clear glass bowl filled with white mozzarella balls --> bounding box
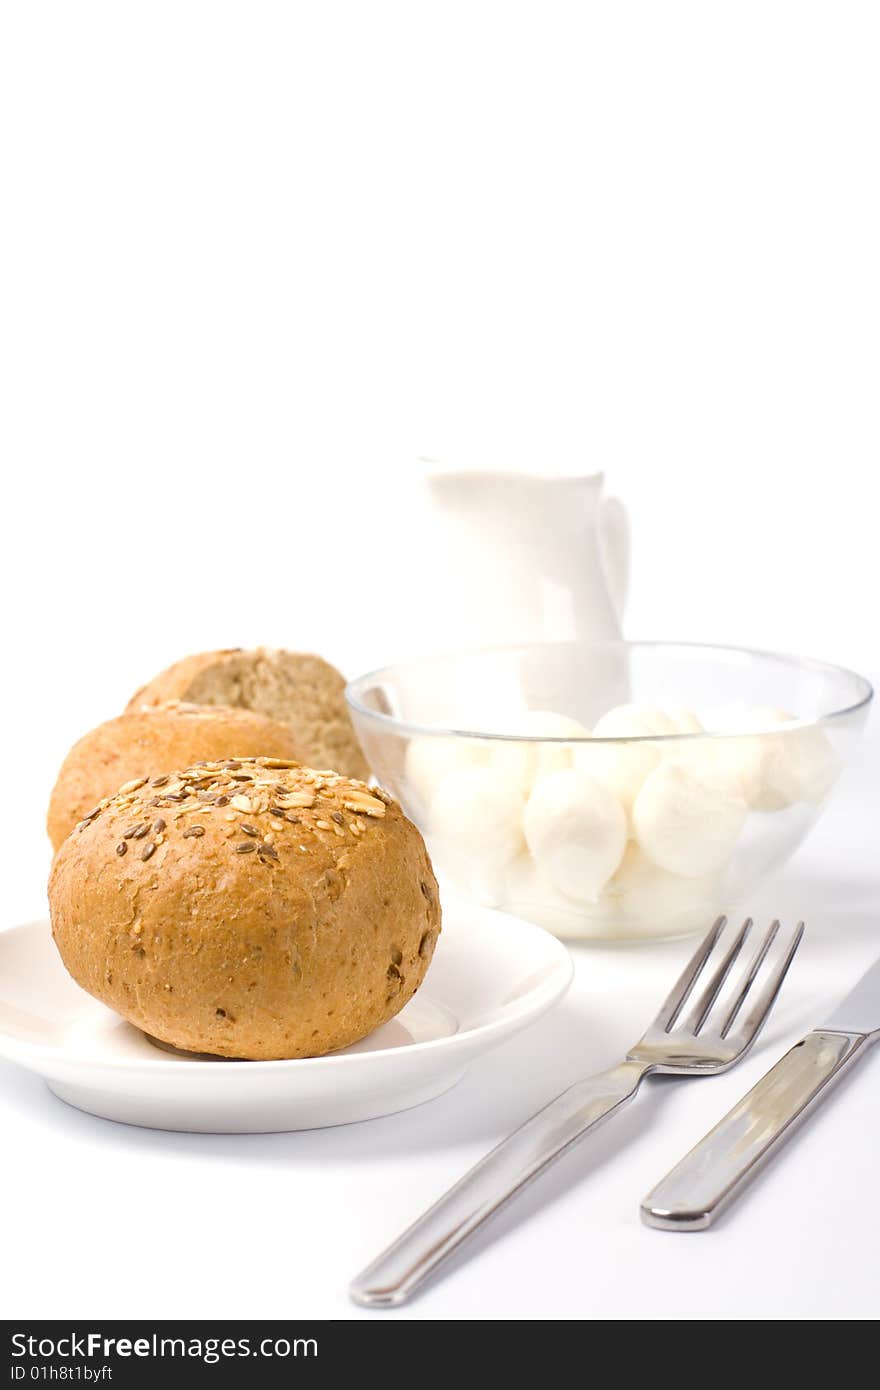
[346,642,873,940]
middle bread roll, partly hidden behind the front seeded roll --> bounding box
[46,701,299,849]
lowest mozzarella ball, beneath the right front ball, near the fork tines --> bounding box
[605,842,719,937]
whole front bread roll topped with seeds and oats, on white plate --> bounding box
[49,758,441,1059]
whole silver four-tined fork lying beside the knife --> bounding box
[350,917,804,1308]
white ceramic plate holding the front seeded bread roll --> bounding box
[0,902,571,1133]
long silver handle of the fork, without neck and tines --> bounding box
[350,1061,648,1308]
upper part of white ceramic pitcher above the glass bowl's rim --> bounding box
[421,459,630,649]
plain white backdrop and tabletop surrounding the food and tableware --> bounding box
[0,0,880,1318]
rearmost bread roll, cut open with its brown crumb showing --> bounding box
[128,646,370,778]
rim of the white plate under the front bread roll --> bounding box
[0,902,574,1077]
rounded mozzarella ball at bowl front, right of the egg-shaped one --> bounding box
[633,759,748,878]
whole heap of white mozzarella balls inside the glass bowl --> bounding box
[406,705,838,937]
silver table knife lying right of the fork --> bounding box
[642,960,880,1230]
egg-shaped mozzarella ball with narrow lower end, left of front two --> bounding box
[523,767,627,902]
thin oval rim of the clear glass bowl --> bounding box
[345,639,874,745]
